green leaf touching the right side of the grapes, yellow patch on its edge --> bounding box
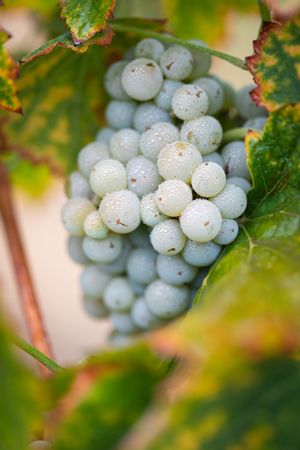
[198,105,300,299]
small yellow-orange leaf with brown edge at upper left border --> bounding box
[0,27,22,113]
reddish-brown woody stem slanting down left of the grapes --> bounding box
[0,161,52,376]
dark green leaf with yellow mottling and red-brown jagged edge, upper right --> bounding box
[246,16,300,111]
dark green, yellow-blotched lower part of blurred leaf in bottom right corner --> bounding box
[142,357,300,450]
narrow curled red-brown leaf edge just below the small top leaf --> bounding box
[20,25,114,65]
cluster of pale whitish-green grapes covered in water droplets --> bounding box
[62,39,265,342]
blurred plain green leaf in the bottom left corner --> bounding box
[0,312,40,450]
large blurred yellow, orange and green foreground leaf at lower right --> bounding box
[137,250,300,450]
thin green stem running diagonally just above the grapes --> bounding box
[110,22,248,70]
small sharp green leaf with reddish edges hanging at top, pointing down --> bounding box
[62,0,115,44]
